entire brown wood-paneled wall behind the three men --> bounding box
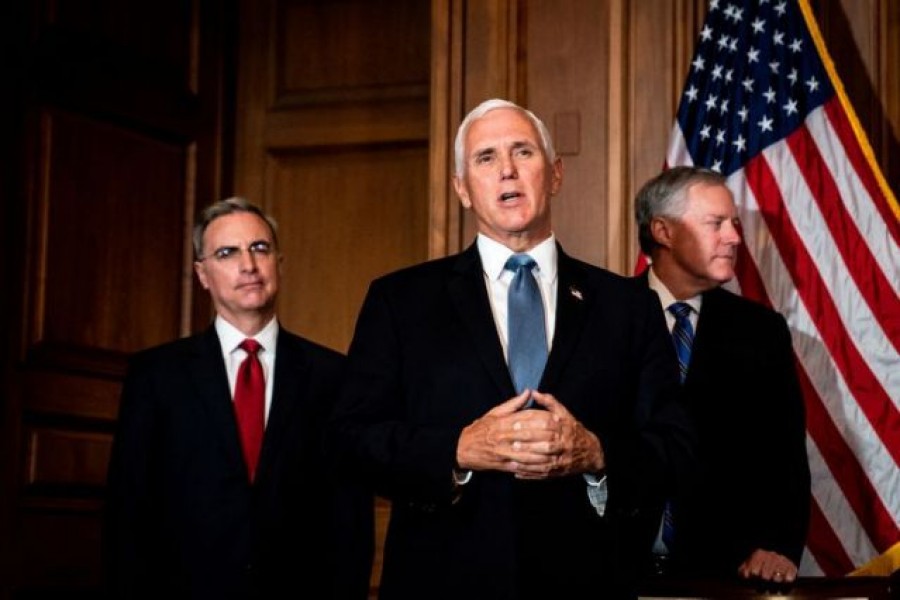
[0,0,900,600]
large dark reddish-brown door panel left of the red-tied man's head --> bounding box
[28,111,191,364]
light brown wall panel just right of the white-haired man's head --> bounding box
[522,0,619,264]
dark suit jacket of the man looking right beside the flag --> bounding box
[643,276,810,577]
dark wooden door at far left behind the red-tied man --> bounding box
[0,0,227,599]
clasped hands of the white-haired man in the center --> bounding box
[456,390,606,479]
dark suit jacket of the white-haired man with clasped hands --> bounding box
[335,245,692,599]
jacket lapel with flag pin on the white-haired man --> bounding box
[539,247,594,390]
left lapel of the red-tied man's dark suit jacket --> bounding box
[189,327,245,468]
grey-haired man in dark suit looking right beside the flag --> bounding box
[635,167,810,582]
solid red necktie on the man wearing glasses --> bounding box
[234,339,266,481]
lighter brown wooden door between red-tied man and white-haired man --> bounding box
[234,0,430,591]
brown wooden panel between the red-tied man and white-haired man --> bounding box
[266,144,428,352]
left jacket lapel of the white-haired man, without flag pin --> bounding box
[447,244,515,398]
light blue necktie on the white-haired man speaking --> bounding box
[504,254,547,406]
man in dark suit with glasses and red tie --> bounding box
[105,198,374,599]
